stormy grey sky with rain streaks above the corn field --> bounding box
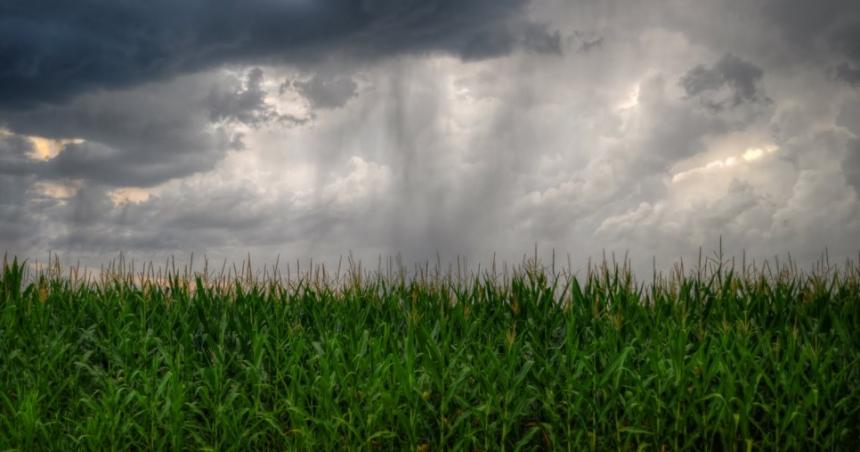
[0,0,860,267]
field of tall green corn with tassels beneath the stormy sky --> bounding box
[0,254,860,451]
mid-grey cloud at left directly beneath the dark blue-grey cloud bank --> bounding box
[0,76,244,186]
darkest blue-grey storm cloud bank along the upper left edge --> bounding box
[0,0,558,108]
